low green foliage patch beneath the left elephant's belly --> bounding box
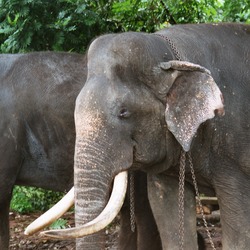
[10,186,63,213]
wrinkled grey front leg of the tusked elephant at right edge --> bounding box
[214,165,250,250]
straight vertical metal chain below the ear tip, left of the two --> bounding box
[178,151,186,250]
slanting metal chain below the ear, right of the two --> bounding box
[187,152,216,250]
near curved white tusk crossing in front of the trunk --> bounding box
[40,171,128,239]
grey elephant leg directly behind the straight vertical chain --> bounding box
[148,174,198,250]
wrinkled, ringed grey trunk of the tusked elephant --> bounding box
[74,137,116,249]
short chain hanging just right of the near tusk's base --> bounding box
[129,172,135,233]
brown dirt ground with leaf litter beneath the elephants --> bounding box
[10,212,222,250]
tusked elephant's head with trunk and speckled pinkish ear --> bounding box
[40,33,223,249]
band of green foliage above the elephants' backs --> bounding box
[0,0,250,53]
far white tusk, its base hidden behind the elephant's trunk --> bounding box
[24,187,74,235]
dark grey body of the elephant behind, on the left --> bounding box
[0,52,86,250]
